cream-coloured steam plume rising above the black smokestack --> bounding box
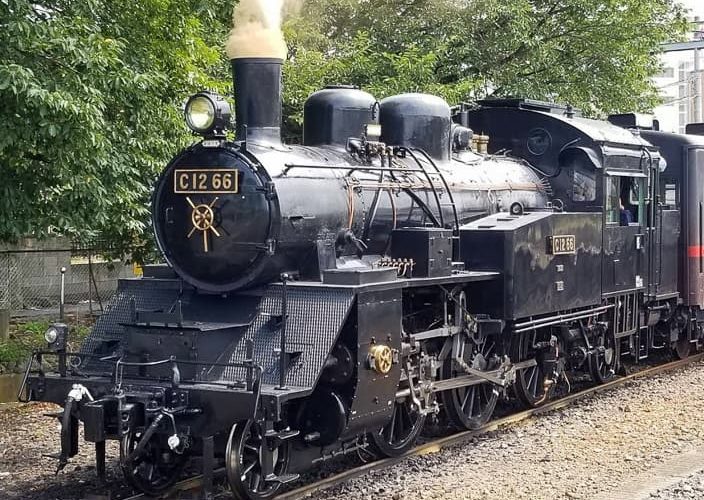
[226,0,288,59]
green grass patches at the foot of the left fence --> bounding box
[0,319,90,373]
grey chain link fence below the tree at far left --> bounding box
[0,245,135,317]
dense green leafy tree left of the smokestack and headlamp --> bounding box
[0,0,230,256]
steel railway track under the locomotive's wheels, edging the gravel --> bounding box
[117,353,704,500]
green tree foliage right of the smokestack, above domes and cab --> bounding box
[287,0,686,132]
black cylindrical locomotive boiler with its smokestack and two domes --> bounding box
[153,58,546,293]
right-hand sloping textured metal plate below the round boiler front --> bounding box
[222,285,354,387]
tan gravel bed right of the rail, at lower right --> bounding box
[311,363,704,500]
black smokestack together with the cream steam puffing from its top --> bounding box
[227,0,287,143]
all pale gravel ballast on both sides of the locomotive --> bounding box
[0,363,704,500]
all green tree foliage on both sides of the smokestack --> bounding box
[0,0,685,247]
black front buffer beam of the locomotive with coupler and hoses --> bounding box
[23,352,262,488]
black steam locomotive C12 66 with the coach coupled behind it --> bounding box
[23,54,704,499]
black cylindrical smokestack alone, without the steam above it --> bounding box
[232,57,284,144]
